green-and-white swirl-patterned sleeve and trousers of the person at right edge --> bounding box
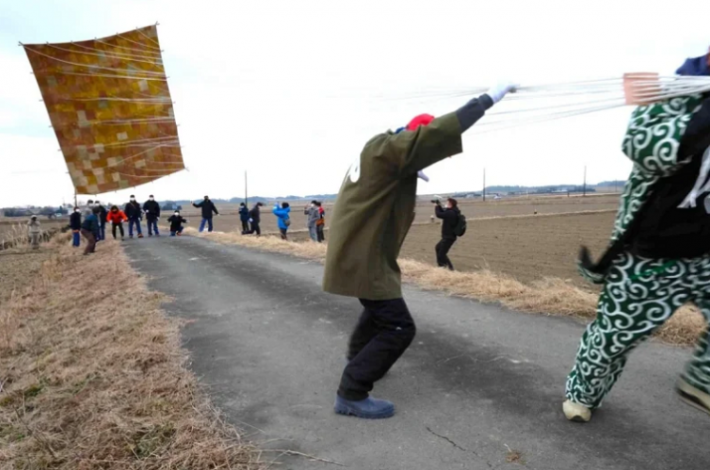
[566,95,710,408]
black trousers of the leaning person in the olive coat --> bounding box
[338,299,417,400]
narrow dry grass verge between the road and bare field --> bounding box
[195,229,706,345]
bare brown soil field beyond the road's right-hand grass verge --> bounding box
[177,194,619,290]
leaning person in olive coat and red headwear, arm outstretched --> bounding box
[323,83,515,418]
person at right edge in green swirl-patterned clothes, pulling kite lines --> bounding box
[563,50,710,422]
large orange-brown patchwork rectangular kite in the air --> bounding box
[23,26,185,195]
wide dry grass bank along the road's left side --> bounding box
[0,234,263,470]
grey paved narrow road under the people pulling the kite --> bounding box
[125,237,710,470]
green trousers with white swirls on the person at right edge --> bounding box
[566,253,710,408]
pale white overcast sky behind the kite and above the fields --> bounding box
[0,0,710,206]
